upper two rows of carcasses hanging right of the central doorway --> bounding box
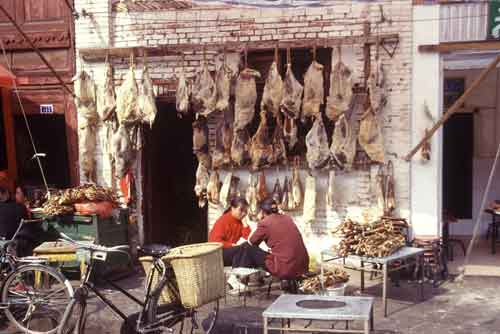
[176,48,387,170]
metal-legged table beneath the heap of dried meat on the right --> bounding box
[320,247,424,317]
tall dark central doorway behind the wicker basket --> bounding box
[143,103,207,246]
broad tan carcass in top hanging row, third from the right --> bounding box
[302,60,325,121]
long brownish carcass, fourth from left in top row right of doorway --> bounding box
[234,68,260,131]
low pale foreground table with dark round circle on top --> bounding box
[262,294,373,334]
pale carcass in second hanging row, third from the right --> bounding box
[306,115,330,169]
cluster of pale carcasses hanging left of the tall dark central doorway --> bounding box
[74,56,157,184]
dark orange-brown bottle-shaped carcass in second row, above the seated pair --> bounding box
[250,112,275,170]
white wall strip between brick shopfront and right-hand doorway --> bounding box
[410,5,443,235]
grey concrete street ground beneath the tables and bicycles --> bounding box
[0,245,500,334]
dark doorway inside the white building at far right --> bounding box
[443,113,474,219]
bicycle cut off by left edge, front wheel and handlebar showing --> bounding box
[0,219,73,334]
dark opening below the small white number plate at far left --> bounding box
[14,115,70,188]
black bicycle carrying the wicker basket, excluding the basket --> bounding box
[58,234,219,334]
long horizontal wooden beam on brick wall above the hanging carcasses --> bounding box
[79,34,399,61]
